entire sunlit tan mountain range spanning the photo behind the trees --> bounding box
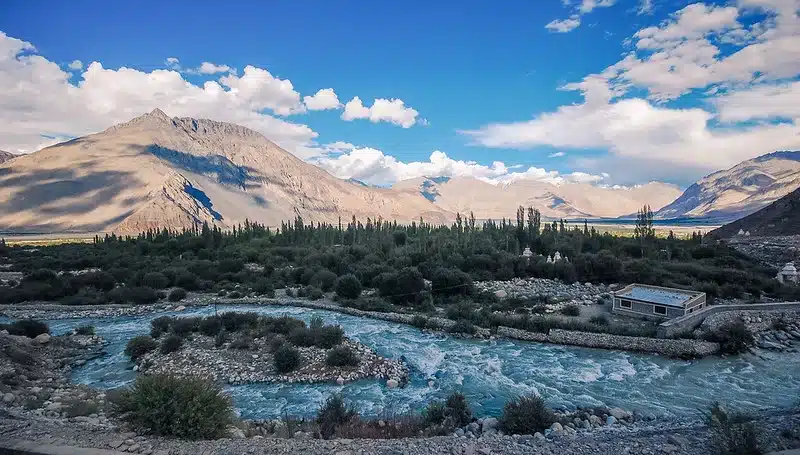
[0,109,800,234]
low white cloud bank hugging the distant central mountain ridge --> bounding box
[315,144,608,185]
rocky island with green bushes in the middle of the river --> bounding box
[132,312,409,388]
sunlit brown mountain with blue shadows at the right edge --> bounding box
[656,151,800,222]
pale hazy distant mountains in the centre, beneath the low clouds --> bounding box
[392,177,681,219]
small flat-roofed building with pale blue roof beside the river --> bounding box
[611,284,706,320]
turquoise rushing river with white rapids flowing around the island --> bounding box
[36,305,800,419]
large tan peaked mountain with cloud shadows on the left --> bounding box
[0,109,454,233]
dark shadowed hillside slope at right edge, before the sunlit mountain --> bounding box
[709,188,800,238]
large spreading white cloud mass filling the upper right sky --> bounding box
[464,0,800,181]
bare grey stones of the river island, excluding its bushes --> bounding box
[136,334,408,387]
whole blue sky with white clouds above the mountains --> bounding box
[0,0,800,187]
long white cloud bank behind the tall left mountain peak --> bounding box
[0,32,317,154]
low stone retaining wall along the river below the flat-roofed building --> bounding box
[497,327,719,357]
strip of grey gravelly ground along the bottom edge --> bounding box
[0,414,800,455]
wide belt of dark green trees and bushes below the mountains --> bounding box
[0,207,800,310]
